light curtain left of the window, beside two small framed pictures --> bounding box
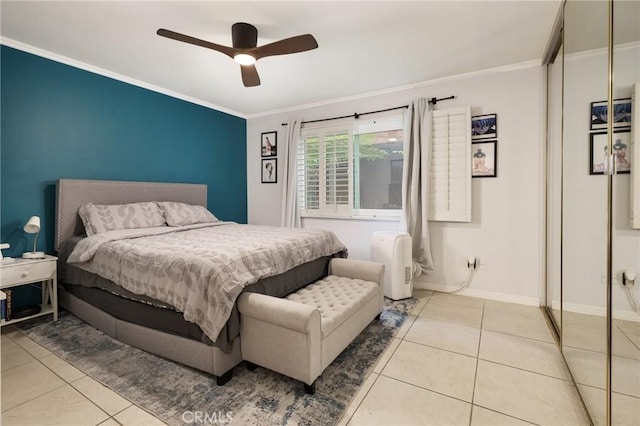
[280,120,301,228]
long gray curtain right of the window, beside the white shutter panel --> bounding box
[401,98,433,276]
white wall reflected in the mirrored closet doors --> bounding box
[562,43,640,319]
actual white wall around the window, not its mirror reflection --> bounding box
[247,66,544,304]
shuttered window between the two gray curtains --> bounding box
[298,114,403,217]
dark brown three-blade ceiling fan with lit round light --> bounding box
[157,22,318,87]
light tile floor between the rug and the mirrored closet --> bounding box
[340,291,590,426]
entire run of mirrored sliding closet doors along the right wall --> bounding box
[546,0,640,425]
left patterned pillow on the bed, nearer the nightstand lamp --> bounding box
[78,201,165,236]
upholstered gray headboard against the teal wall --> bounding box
[55,179,207,250]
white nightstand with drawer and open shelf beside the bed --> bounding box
[0,255,58,326]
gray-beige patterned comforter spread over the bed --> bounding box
[68,222,346,342]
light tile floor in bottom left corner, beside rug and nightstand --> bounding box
[0,327,170,426]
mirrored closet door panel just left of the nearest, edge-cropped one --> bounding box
[561,1,609,424]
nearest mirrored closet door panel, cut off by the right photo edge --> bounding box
[610,1,640,425]
